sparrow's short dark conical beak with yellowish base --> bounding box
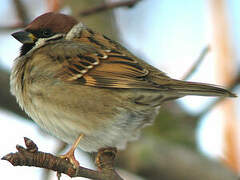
[12,31,37,44]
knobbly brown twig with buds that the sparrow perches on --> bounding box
[2,137,122,180]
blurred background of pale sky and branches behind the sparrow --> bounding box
[0,0,240,180]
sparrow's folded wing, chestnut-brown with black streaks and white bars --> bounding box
[46,41,161,89]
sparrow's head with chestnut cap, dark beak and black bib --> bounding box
[12,12,78,55]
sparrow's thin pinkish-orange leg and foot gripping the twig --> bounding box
[60,134,84,168]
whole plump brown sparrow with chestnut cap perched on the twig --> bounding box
[10,12,236,166]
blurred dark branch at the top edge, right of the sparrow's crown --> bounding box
[79,0,141,16]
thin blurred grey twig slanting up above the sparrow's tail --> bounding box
[182,46,210,80]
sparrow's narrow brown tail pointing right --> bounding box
[163,79,237,97]
